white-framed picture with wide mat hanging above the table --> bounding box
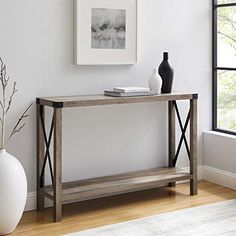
[74,0,138,65]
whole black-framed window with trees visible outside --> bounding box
[213,0,236,134]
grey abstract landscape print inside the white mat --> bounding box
[91,8,126,49]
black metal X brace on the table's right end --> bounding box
[173,101,190,166]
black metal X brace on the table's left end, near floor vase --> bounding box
[40,107,54,188]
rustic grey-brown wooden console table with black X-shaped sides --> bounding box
[36,92,198,222]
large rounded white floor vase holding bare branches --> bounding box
[0,150,27,235]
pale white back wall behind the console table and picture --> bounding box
[0,0,211,192]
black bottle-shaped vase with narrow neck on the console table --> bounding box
[158,52,174,93]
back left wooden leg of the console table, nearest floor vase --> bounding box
[36,104,45,211]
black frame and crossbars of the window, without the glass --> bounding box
[212,0,236,135]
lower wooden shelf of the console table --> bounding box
[44,167,193,204]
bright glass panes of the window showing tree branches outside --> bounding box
[217,0,236,132]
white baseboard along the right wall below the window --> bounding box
[203,165,236,190]
